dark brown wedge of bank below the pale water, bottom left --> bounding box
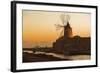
[23,52,69,62]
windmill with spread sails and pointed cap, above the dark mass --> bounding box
[55,14,72,38]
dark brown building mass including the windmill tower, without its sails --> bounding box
[53,21,91,55]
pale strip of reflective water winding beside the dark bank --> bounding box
[24,51,91,60]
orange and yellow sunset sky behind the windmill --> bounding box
[23,10,91,48]
